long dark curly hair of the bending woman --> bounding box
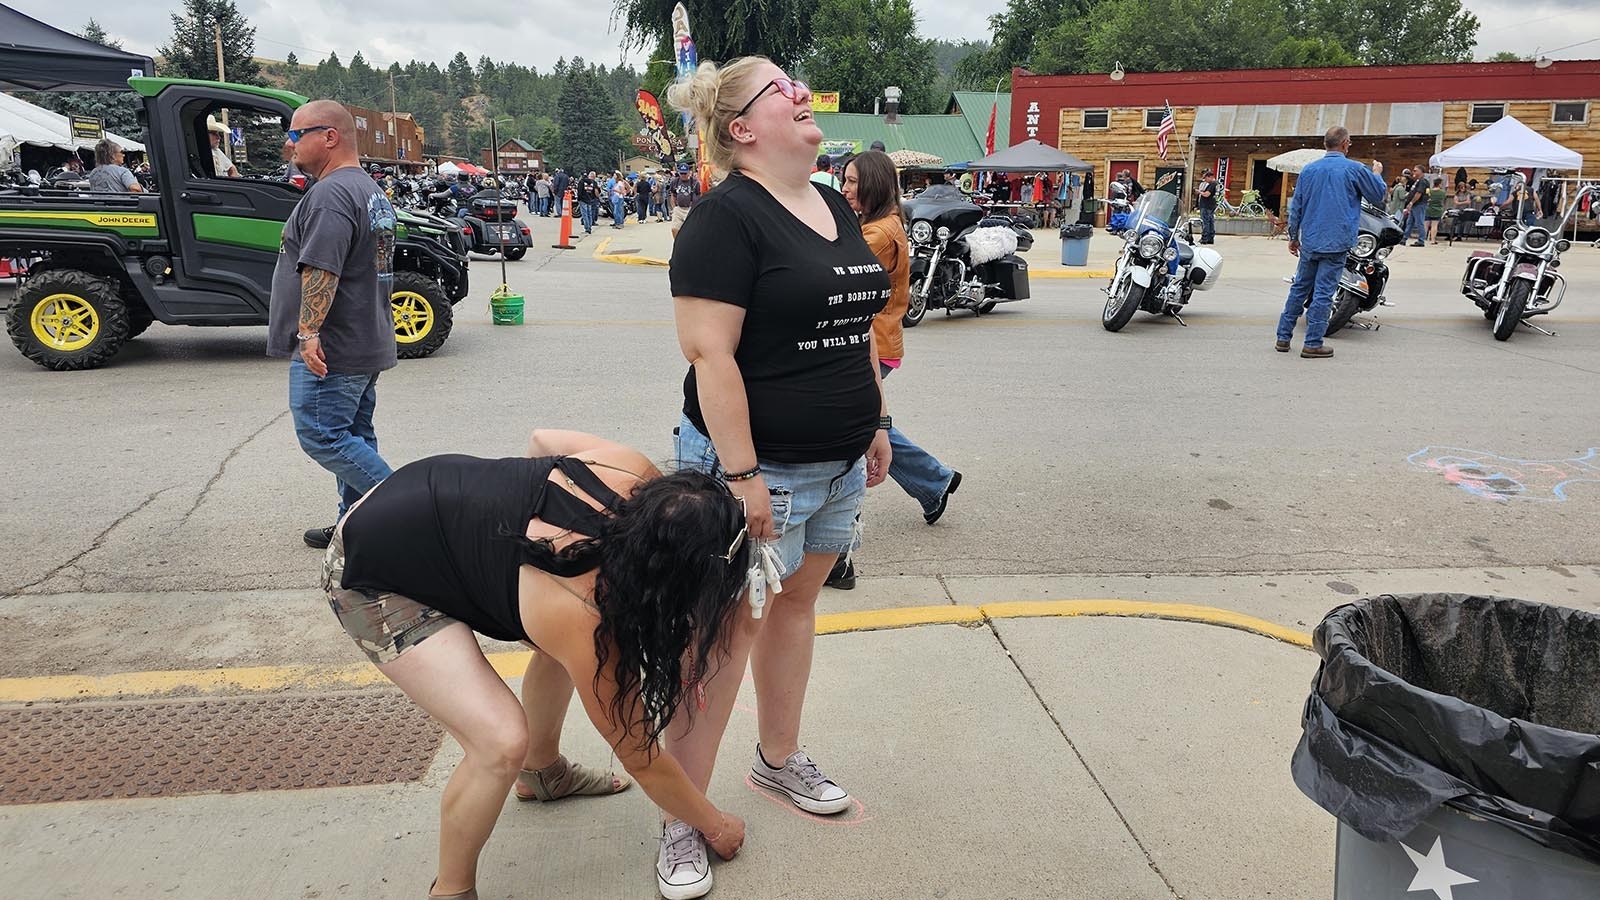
[525,471,750,753]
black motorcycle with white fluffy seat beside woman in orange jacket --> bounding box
[901,184,1034,328]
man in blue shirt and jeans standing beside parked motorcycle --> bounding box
[1274,125,1384,359]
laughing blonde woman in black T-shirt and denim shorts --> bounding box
[656,58,891,900]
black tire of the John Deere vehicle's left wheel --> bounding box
[6,269,130,372]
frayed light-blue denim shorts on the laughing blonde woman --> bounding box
[677,416,867,578]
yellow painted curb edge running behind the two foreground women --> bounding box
[0,599,1310,703]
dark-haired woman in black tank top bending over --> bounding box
[323,431,750,900]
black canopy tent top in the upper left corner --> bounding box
[0,5,155,91]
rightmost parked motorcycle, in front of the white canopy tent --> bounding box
[1461,177,1600,341]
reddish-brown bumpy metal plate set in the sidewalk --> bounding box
[0,690,443,804]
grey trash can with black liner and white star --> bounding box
[1291,594,1600,900]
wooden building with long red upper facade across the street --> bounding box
[1011,59,1600,217]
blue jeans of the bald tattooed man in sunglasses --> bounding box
[290,359,394,517]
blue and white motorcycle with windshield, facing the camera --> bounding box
[1101,191,1222,331]
